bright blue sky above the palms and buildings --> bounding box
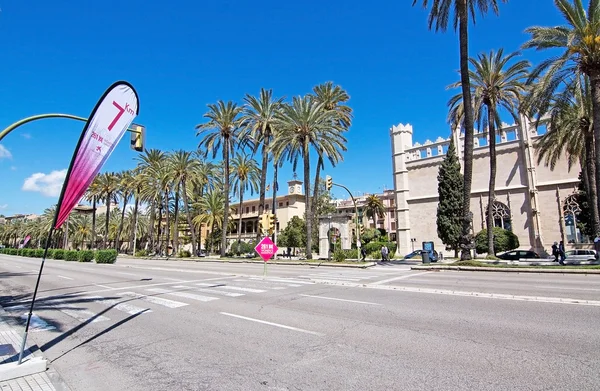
[0,0,562,215]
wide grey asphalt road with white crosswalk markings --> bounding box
[0,255,600,391]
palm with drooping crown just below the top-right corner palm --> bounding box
[526,73,600,232]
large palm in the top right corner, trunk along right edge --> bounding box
[523,0,600,236]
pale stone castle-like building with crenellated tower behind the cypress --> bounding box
[390,118,589,256]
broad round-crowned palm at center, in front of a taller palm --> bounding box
[271,96,346,259]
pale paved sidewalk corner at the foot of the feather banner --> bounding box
[0,307,69,391]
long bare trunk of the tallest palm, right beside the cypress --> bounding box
[456,0,476,261]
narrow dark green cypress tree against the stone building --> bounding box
[437,138,463,257]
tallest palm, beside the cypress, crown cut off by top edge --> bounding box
[413,0,508,260]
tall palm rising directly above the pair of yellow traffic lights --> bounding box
[240,88,284,224]
